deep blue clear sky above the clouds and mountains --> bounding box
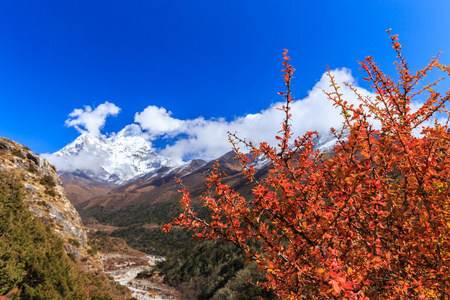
[0,0,450,161]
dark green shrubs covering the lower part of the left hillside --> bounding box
[0,174,89,299]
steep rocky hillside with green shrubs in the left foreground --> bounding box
[0,138,135,299]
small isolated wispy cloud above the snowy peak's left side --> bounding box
[65,101,120,137]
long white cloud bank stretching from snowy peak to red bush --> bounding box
[135,69,371,160]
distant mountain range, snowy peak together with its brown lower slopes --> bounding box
[46,124,342,223]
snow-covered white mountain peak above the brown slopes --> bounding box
[46,124,177,184]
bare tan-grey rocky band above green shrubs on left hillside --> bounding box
[0,137,98,265]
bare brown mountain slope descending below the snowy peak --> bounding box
[72,131,336,226]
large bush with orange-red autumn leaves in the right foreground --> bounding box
[164,32,450,299]
